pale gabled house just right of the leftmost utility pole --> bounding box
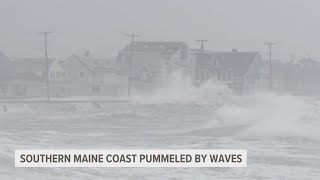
[49,54,126,97]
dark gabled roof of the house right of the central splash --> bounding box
[198,52,259,76]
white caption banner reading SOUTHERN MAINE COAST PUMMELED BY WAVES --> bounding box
[15,149,247,167]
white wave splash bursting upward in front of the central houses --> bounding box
[132,71,232,104]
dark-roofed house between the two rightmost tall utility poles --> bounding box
[195,49,267,93]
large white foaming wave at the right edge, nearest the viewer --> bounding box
[207,93,320,138]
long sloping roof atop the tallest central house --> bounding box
[120,41,185,54]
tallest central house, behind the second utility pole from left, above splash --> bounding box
[116,41,194,91]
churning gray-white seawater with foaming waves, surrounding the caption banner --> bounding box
[0,78,320,180]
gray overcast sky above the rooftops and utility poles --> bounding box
[0,0,320,60]
